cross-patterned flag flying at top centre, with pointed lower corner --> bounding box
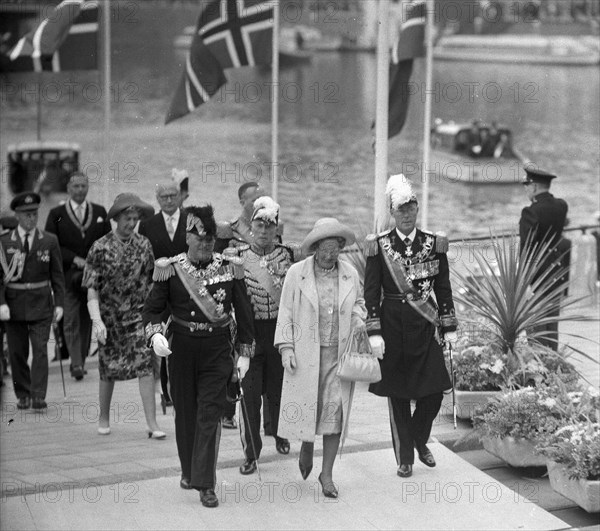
[165,0,273,124]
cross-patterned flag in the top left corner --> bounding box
[8,0,98,72]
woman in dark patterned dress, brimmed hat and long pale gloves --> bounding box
[83,194,166,439]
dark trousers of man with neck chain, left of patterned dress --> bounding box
[63,288,92,368]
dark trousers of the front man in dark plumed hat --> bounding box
[169,332,233,490]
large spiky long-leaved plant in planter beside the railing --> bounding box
[454,235,595,378]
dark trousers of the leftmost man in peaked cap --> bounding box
[5,317,52,399]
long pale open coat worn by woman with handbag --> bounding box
[274,257,367,442]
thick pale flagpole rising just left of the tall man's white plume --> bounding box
[373,0,390,230]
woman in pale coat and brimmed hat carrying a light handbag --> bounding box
[275,218,367,498]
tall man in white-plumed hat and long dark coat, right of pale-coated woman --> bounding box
[365,174,457,478]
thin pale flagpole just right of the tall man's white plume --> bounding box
[421,0,435,233]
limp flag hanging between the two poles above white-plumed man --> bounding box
[388,1,427,138]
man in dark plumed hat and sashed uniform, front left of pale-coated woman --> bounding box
[144,206,254,507]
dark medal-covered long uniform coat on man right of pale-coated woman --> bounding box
[365,229,457,399]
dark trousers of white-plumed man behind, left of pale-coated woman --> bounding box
[240,319,283,459]
